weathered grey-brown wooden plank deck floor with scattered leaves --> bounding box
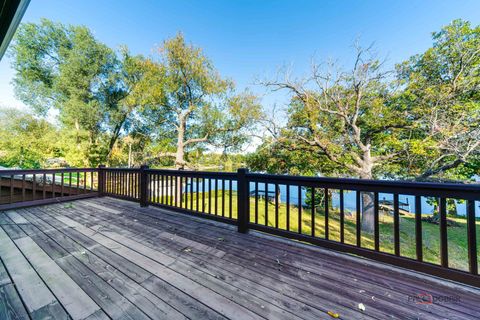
[0,198,480,320]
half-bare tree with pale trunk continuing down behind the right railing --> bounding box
[264,48,409,231]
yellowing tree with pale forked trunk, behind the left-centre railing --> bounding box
[135,34,260,169]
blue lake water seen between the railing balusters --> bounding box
[177,179,480,217]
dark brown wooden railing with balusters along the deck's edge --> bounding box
[0,166,480,287]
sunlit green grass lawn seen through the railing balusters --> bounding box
[156,190,480,271]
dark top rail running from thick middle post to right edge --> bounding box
[247,173,480,200]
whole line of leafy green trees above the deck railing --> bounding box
[0,19,480,184]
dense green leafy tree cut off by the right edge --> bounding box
[397,20,480,180]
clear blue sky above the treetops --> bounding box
[0,0,480,114]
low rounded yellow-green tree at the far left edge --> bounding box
[0,108,62,168]
